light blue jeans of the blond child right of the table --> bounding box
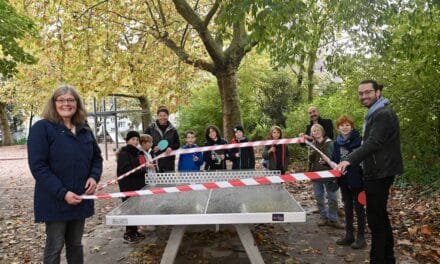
[313,181,338,222]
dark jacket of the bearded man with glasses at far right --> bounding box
[346,106,403,181]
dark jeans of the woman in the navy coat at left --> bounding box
[43,219,85,264]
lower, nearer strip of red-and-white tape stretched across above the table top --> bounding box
[81,170,341,199]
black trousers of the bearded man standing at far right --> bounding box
[365,176,396,264]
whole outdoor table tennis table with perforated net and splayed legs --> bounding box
[106,171,306,264]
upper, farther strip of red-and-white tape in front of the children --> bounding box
[97,137,304,191]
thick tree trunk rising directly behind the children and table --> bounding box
[216,69,241,142]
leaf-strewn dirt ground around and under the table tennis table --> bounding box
[0,146,417,264]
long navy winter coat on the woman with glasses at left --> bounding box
[27,119,102,222]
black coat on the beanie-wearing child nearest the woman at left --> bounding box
[116,145,145,192]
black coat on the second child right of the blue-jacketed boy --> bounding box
[229,138,255,170]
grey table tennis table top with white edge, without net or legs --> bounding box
[106,184,306,225]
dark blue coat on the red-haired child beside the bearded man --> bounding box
[332,129,364,188]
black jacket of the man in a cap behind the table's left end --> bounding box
[145,121,180,172]
